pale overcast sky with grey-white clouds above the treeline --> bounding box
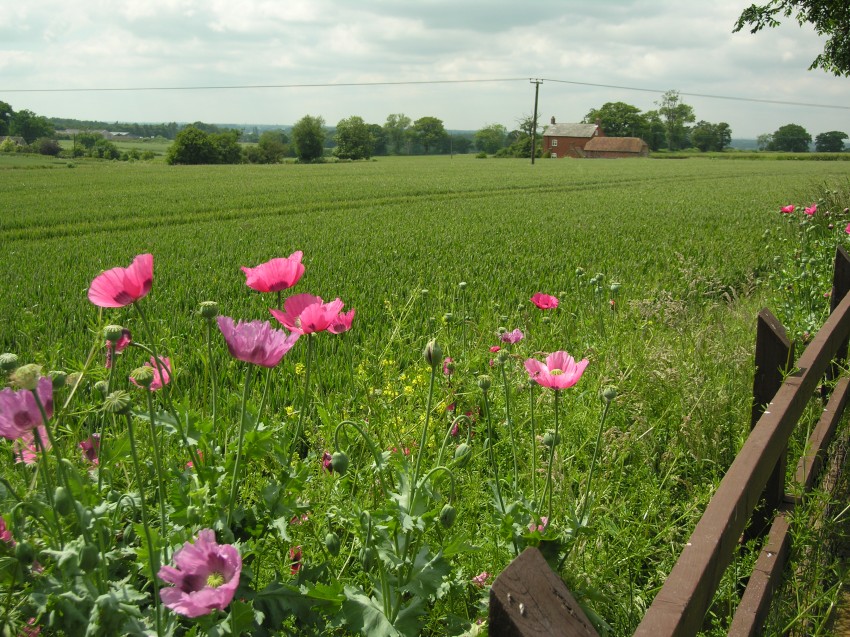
[0,0,850,138]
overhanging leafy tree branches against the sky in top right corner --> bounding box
[733,0,850,76]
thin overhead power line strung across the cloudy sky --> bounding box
[0,77,850,110]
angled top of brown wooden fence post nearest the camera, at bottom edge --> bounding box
[488,547,599,637]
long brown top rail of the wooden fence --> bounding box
[635,295,850,637]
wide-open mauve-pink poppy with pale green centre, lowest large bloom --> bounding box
[158,529,242,617]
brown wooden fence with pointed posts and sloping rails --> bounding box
[489,247,850,637]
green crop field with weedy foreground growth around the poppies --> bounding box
[0,156,850,635]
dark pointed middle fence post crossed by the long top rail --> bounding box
[744,308,794,541]
